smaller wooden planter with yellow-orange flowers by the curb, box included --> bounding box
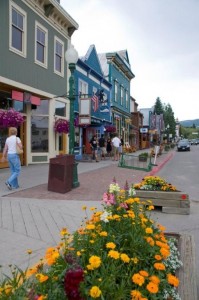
[134,176,190,214]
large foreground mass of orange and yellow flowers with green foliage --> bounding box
[0,181,182,300]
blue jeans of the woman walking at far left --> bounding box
[7,154,21,189]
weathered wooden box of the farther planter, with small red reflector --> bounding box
[136,190,190,215]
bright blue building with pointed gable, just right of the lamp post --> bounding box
[75,45,112,158]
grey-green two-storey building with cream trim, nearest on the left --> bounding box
[0,0,78,165]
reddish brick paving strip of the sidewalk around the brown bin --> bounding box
[6,151,174,201]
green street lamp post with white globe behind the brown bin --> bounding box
[65,45,79,188]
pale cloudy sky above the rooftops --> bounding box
[60,0,199,121]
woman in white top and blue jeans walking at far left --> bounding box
[1,127,22,190]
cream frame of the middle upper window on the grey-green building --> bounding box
[35,21,48,69]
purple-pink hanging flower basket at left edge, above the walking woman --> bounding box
[0,108,24,128]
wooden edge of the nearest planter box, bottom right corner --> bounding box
[166,233,199,300]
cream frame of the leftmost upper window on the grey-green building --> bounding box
[9,1,27,57]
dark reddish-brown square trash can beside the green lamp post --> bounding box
[48,154,75,194]
